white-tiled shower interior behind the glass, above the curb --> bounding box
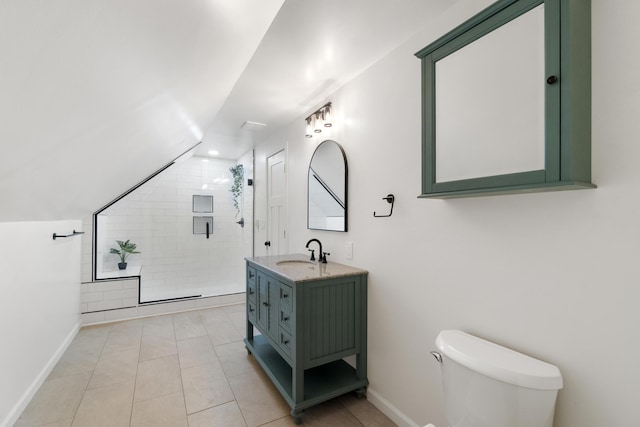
[95,152,253,303]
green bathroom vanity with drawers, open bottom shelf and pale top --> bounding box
[244,255,368,424]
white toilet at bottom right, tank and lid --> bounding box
[425,330,562,427]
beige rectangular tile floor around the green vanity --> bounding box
[15,305,395,427]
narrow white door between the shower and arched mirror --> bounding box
[265,150,289,255]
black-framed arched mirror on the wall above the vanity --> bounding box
[307,139,347,231]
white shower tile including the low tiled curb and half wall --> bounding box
[80,152,253,324]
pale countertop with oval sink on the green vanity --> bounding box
[245,254,368,282]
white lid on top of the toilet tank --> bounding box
[436,330,562,390]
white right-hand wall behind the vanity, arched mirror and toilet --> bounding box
[255,0,640,427]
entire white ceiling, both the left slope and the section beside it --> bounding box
[0,0,454,222]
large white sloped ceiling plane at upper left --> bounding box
[0,0,284,221]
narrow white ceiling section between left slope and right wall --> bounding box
[197,0,452,159]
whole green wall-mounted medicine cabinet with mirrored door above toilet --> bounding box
[416,0,595,198]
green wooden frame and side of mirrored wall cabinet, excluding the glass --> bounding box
[415,0,595,198]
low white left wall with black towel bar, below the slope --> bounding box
[0,220,82,426]
